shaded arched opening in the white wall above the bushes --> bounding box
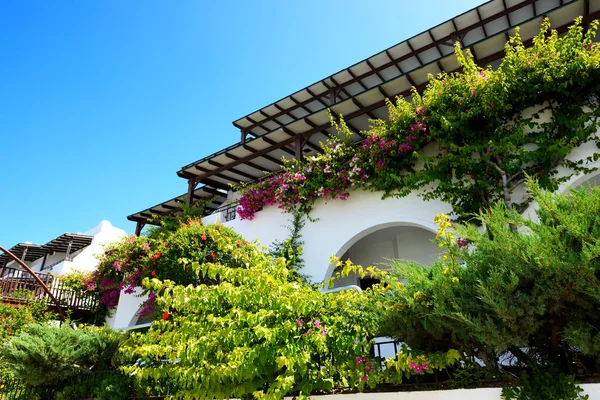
[329,224,440,289]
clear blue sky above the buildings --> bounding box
[0,0,483,246]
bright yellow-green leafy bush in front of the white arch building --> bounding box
[124,233,408,399]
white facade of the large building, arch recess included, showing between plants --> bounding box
[111,135,600,328]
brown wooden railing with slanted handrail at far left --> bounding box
[0,267,96,310]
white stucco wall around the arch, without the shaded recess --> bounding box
[211,190,451,282]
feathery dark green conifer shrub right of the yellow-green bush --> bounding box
[383,182,600,390]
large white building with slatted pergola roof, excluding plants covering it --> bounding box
[114,0,600,326]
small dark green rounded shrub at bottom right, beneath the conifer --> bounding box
[502,370,589,400]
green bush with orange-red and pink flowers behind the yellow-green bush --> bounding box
[88,218,247,313]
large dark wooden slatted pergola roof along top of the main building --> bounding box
[128,0,600,231]
